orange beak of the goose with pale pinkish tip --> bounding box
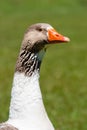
[48,29,70,43]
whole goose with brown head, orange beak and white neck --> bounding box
[0,23,70,130]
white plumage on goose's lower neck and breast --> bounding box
[7,71,54,130]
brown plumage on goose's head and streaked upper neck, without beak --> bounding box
[15,23,51,76]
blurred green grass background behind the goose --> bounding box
[0,0,87,130]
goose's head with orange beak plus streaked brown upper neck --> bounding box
[16,23,70,76]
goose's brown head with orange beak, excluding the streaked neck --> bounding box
[22,23,70,52]
